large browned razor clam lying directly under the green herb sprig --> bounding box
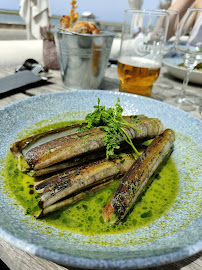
[13,116,163,170]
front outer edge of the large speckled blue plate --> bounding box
[0,217,202,269]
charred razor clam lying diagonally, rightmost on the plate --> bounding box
[103,129,175,224]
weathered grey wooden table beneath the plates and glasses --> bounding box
[0,62,202,270]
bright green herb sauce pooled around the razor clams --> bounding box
[5,122,179,235]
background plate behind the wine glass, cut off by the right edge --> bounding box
[163,57,202,84]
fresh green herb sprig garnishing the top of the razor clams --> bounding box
[82,98,140,158]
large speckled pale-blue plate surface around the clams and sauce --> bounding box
[0,90,202,269]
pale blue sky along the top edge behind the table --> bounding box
[0,0,160,22]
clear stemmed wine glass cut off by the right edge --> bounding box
[174,8,202,111]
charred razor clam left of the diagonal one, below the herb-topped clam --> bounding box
[35,153,138,209]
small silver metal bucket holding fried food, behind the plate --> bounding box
[55,31,114,90]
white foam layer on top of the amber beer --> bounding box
[118,56,161,69]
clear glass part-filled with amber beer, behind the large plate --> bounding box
[118,9,169,97]
